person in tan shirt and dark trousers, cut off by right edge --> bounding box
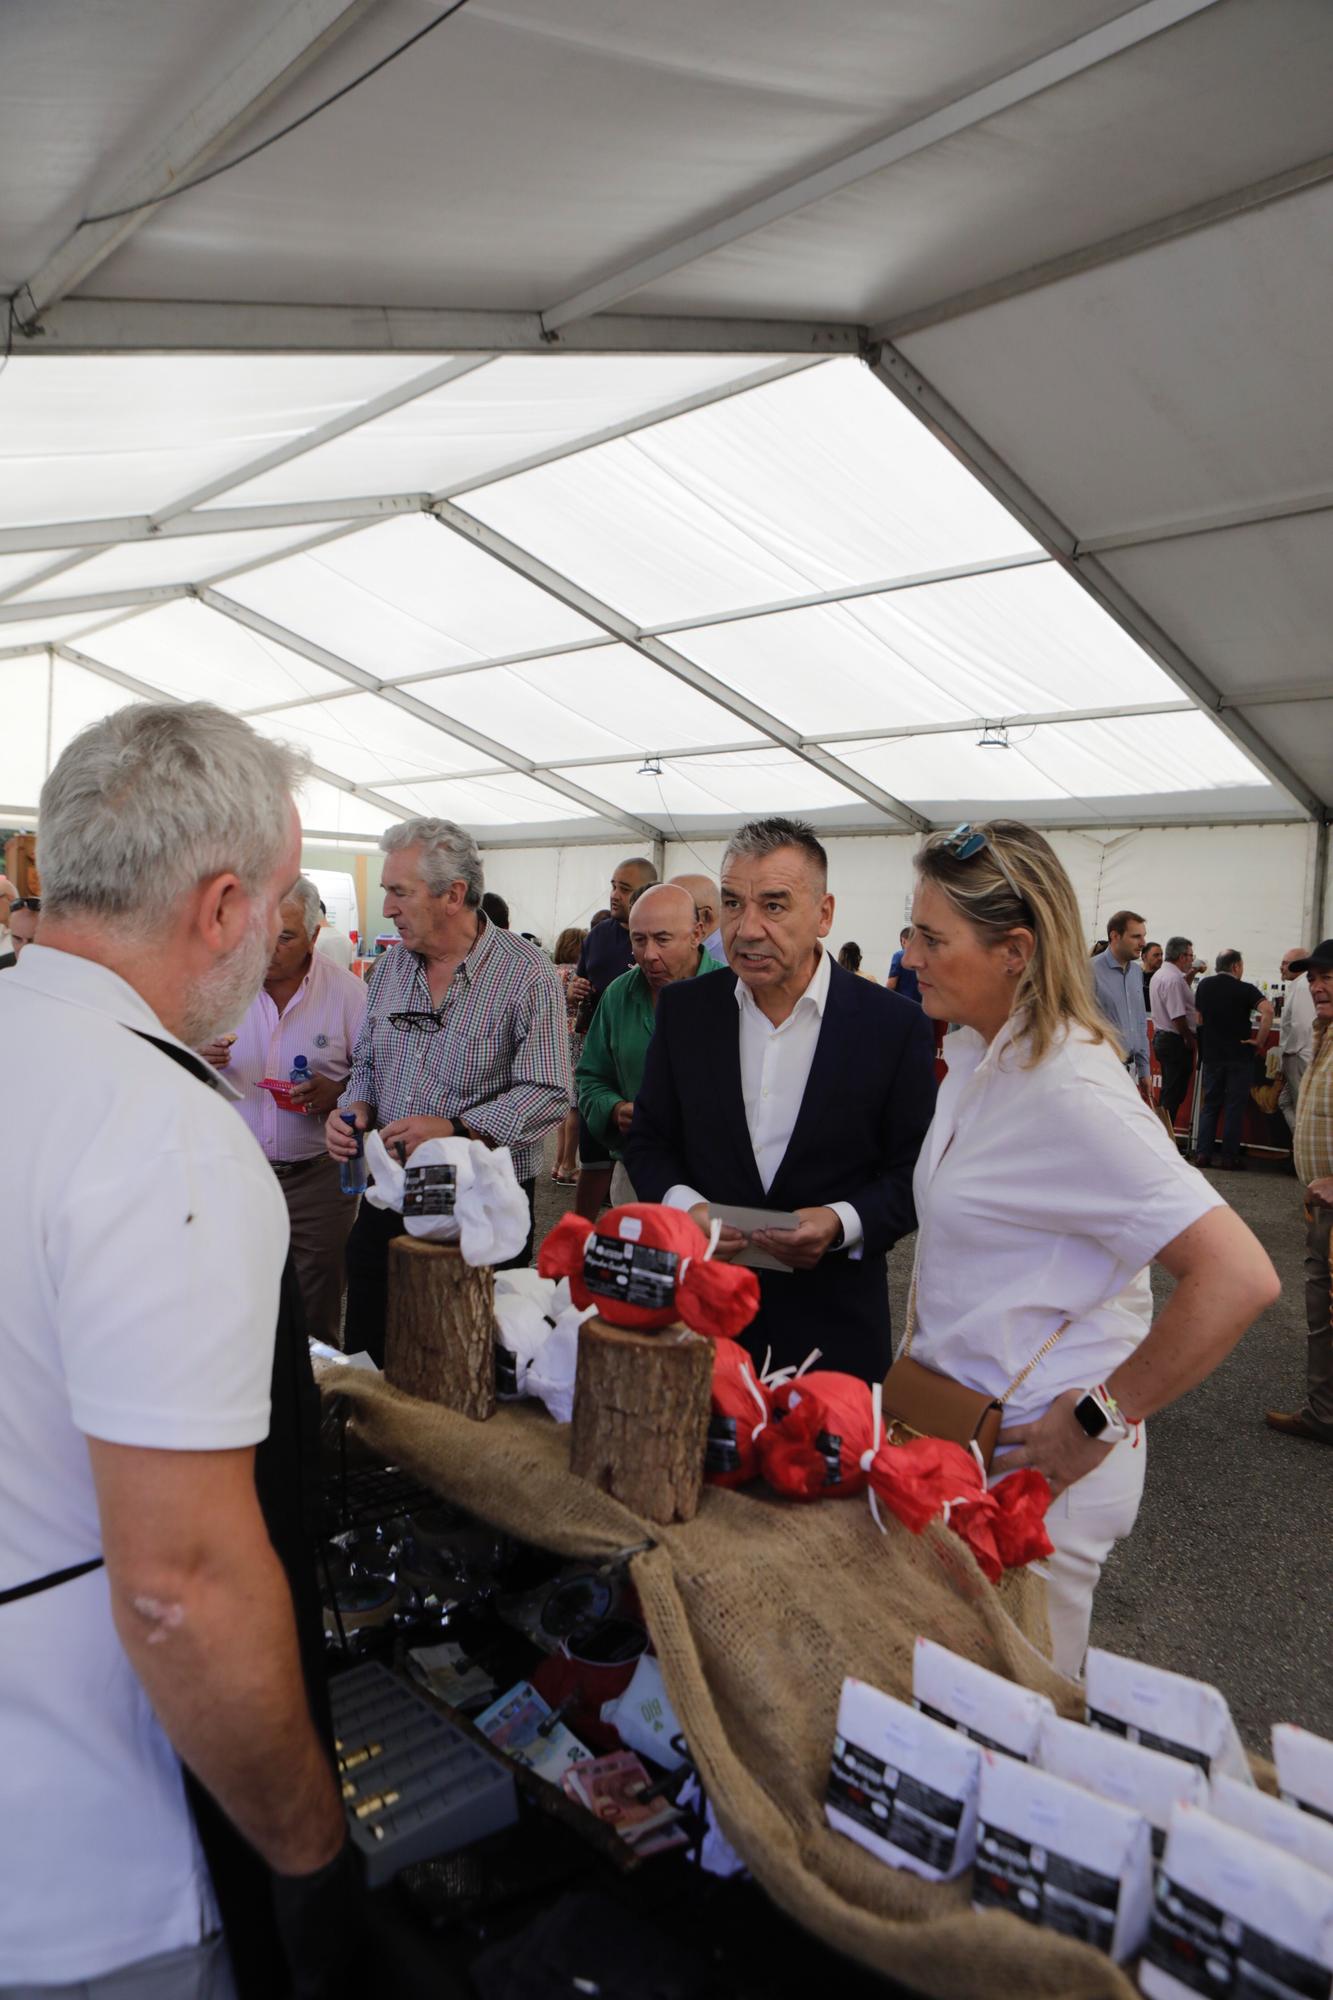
[1265,938,1333,1444]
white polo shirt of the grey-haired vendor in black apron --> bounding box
[0,944,288,1986]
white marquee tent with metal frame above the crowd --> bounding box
[0,0,1333,972]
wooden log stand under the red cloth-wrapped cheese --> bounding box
[568,1318,713,1522]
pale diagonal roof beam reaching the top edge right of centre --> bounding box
[542,0,1215,332]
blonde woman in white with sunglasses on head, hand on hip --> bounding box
[903,820,1279,1674]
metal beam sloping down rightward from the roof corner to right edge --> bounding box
[871,342,1327,818]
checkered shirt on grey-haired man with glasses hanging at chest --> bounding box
[340,924,572,1180]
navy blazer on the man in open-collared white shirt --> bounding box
[624,964,935,1382]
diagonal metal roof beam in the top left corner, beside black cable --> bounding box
[22,0,378,314]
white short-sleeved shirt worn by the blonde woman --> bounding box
[913,1026,1225,1424]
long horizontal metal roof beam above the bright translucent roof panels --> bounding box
[23,298,865,360]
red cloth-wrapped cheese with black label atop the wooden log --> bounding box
[536,1202,759,1340]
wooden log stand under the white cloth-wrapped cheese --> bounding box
[384,1236,494,1422]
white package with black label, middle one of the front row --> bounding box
[973,1750,1153,1960]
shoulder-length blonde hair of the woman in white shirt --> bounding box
[917,820,1121,1068]
